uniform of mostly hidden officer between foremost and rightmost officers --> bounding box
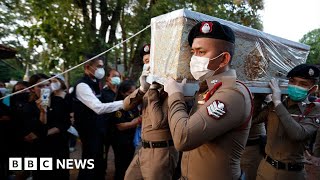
[241,95,266,180]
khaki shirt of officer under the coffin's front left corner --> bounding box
[124,89,172,141]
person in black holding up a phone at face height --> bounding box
[19,74,50,180]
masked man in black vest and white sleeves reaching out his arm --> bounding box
[73,57,123,180]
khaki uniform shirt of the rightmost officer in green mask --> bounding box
[259,100,320,163]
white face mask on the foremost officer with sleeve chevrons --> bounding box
[190,53,224,81]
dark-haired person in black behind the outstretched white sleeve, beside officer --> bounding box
[112,80,141,180]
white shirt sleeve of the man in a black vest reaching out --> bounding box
[76,83,123,114]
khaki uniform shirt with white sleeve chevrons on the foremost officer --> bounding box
[169,70,251,180]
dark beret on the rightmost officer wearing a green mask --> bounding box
[287,64,320,80]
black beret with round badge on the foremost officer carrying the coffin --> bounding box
[188,21,235,46]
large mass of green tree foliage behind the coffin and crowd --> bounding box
[0,0,263,83]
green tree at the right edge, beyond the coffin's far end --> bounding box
[300,28,320,64]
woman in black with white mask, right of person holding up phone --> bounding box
[43,75,71,180]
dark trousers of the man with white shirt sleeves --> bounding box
[78,128,105,180]
